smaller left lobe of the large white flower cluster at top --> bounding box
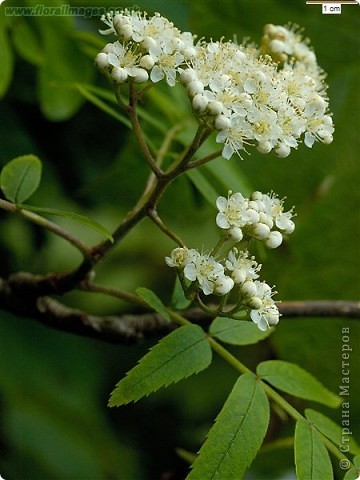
[95,9,196,87]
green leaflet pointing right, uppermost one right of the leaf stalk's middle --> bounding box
[256,360,341,408]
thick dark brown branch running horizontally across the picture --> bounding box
[0,273,360,344]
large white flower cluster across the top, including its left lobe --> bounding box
[95,10,334,159]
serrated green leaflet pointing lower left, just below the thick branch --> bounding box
[109,325,212,407]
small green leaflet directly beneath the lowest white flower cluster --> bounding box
[210,317,272,345]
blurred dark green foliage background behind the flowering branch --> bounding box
[0,0,360,480]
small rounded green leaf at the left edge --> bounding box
[0,155,41,203]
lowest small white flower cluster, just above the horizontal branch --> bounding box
[165,248,280,330]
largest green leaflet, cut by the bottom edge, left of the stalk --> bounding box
[187,373,270,480]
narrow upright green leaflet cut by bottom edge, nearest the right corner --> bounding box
[295,420,334,480]
